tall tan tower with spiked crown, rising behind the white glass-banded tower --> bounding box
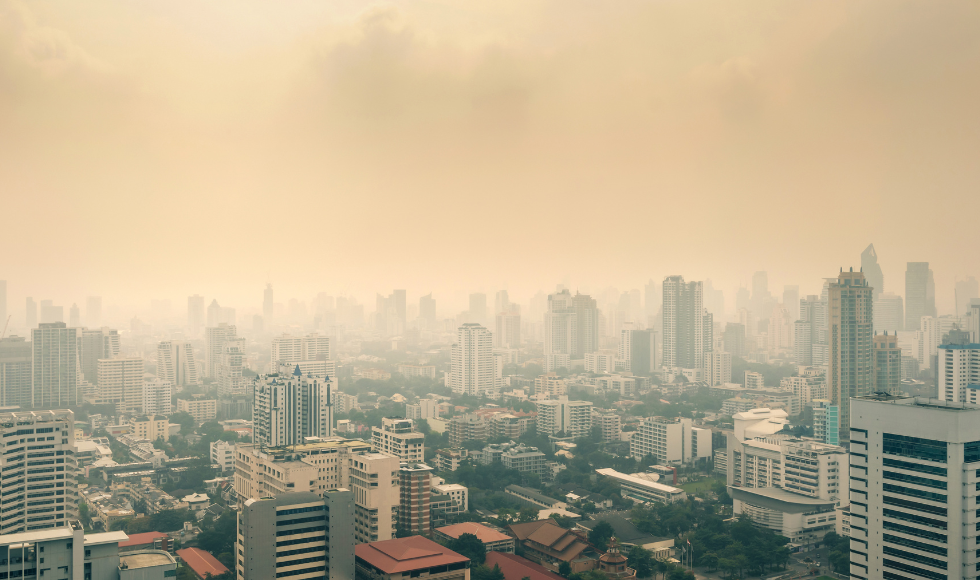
[827,269,874,438]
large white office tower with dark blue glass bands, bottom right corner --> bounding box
[850,395,980,579]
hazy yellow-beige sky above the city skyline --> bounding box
[0,0,980,313]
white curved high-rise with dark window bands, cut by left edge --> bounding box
[0,410,78,535]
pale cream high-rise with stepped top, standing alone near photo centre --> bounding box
[449,322,497,397]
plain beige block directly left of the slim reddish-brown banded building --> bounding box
[350,453,401,544]
